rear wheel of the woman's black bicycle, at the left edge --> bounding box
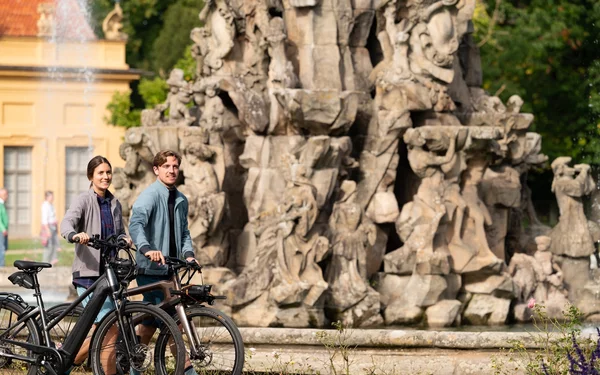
[0,300,40,375]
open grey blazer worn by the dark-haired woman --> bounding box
[60,188,125,278]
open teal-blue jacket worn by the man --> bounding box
[129,180,194,275]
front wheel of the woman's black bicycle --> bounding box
[90,302,185,375]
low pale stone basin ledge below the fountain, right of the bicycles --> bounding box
[240,327,558,375]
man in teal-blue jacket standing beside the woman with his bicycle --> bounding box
[129,150,196,375]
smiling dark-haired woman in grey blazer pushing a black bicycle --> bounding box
[60,156,131,370]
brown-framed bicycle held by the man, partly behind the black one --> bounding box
[55,257,244,375]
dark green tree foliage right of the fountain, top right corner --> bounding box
[474,0,600,164]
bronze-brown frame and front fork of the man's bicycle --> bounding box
[123,271,200,356]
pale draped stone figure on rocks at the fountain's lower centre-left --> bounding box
[231,154,329,326]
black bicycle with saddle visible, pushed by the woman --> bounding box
[0,235,186,375]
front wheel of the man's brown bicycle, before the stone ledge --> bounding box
[161,306,244,375]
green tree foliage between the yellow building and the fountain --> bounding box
[91,0,204,128]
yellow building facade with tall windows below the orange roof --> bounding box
[0,35,139,238]
